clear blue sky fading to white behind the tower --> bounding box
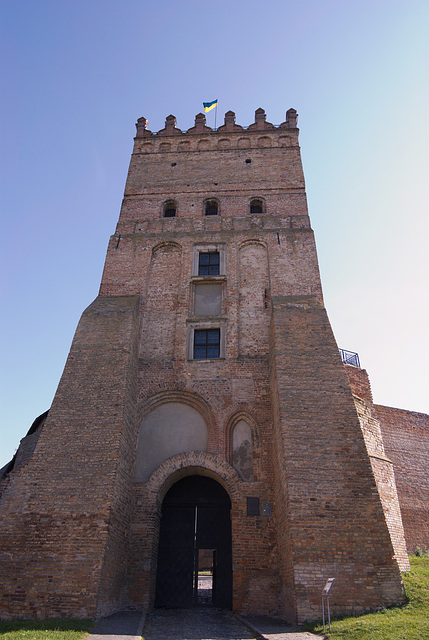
[0,0,429,467]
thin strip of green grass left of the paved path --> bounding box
[0,618,93,640]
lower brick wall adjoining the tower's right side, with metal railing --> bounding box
[345,365,429,570]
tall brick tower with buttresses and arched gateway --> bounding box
[0,109,404,622]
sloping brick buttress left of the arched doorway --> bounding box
[0,297,138,617]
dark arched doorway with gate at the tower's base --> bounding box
[155,476,232,609]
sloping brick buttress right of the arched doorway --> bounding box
[273,296,401,620]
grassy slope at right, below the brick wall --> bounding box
[306,554,429,640]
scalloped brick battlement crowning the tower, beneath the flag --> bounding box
[135,108,299,152]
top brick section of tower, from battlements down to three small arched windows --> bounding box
[117,112,309,239]
